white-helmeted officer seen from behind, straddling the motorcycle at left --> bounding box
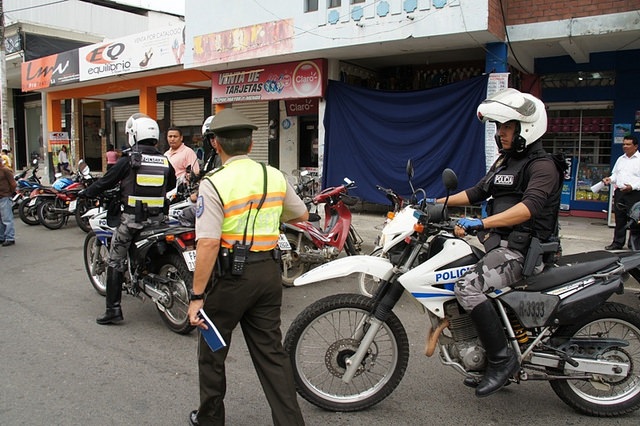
[78,113,176,325]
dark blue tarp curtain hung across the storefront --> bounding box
[322,76,488,204]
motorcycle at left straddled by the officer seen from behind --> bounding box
[83,190,196,334]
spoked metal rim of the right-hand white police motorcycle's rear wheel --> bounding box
[567,318,640,405]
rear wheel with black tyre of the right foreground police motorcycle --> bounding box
[550,303,640,417]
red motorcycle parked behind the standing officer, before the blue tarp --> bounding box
[278,178,362,287]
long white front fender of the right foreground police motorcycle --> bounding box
[293,255,393,287]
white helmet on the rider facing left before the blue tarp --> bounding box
[477,88,547,152]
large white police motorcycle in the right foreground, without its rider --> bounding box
[284,164,640,416]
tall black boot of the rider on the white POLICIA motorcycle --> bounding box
[465,300,520,397]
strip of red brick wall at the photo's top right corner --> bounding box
[504,0,640,25]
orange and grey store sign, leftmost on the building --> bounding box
[21,49,80,92]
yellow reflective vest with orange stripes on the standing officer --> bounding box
[206,158,287,251]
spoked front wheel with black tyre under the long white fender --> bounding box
[284,294,409,412]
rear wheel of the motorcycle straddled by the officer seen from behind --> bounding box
[156,254,195,334]
